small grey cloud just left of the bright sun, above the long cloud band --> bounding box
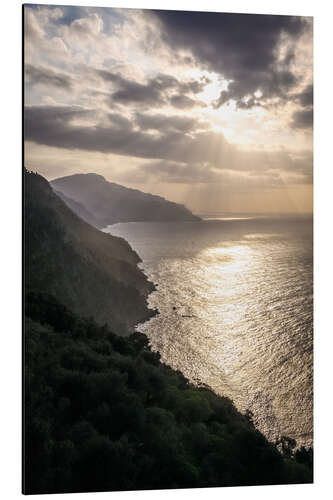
[96,70,209,108]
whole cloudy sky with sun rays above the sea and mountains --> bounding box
[24,5,313,213]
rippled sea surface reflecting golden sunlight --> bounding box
[104,215,313,446]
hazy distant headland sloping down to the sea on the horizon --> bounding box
[50,174,200,227]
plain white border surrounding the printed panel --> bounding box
[0,0,333,500]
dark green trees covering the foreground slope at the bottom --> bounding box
[25,293,312,493]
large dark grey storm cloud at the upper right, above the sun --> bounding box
[152,11,309,107]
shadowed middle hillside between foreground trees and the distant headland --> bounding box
[25,171,153,333]
